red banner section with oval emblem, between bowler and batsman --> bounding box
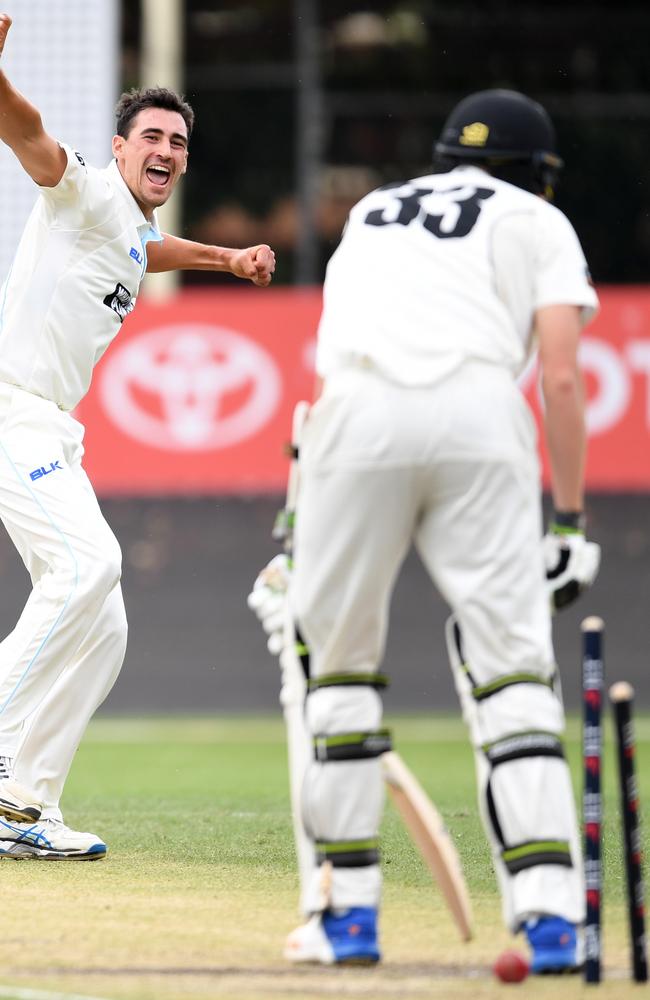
[75,288,321,496]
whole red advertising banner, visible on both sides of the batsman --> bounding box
[76,288,650,496]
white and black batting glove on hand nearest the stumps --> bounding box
[543,511,600,612]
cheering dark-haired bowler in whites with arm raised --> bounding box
[0,14,275,860]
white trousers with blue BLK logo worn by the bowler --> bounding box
[0,383,127,817]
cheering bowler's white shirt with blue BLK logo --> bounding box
[0,144,162,410]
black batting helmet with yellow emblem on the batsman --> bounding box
[433,90,564,199]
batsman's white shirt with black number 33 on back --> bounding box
[316,167,598,386]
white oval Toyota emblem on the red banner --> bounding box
[99,323,282,452]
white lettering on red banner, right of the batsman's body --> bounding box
[519,337,650,436]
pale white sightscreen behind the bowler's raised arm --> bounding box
[0,0,119,284]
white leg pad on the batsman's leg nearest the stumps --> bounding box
[447,619,584,931]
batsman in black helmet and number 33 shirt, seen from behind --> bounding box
[249,90,600,974]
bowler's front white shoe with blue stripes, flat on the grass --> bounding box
[0,818,106,861]
